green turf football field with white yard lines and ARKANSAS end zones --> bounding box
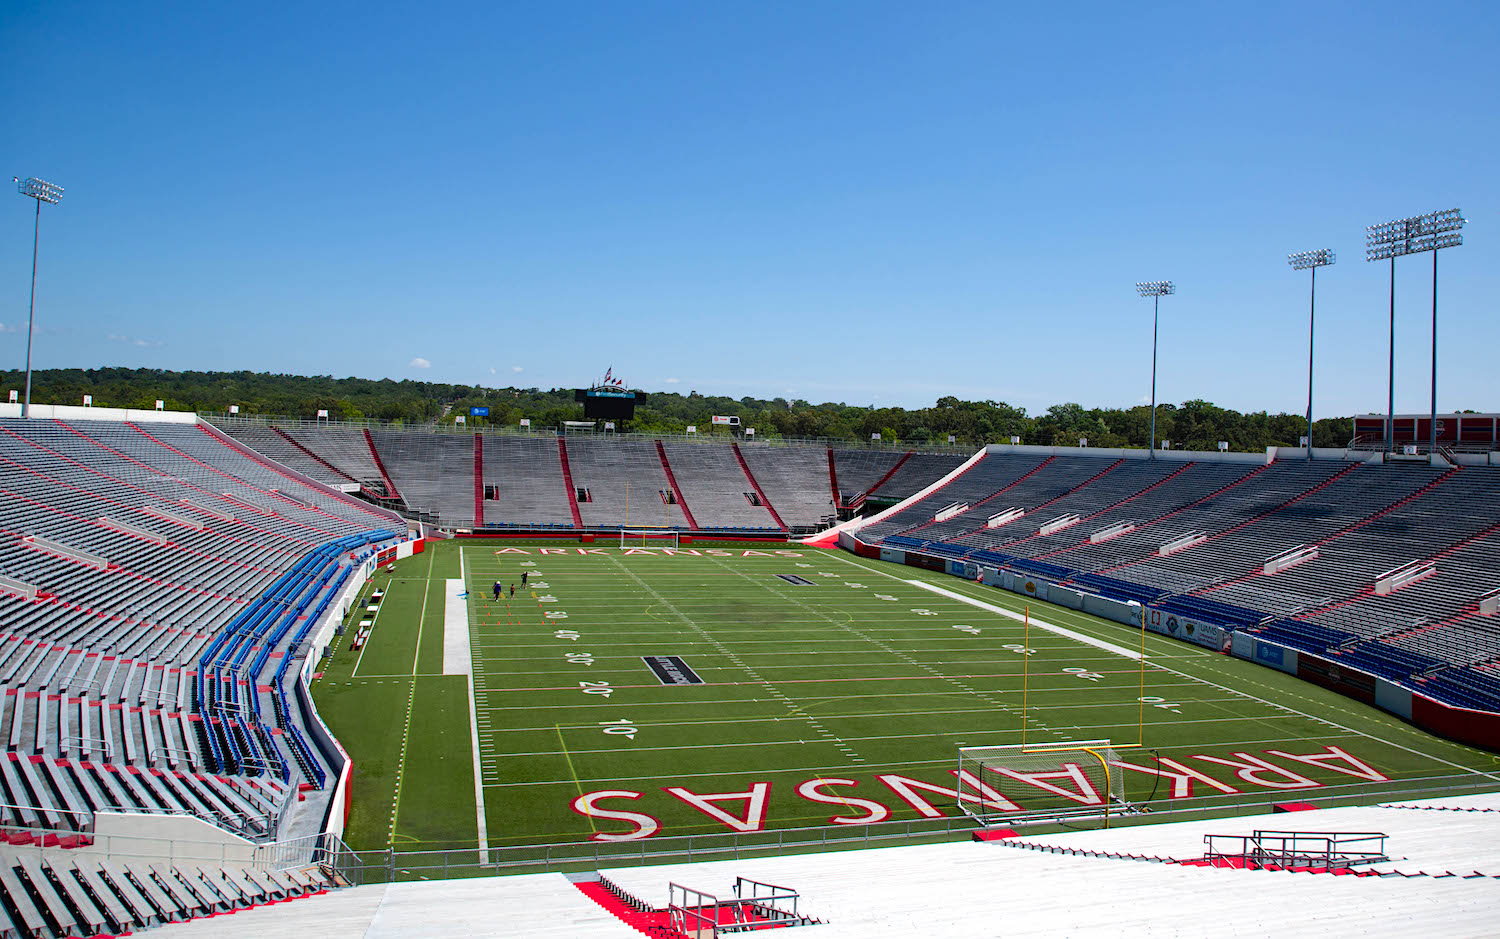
[314,542,1500,849]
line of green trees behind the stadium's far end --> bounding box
[0,368,1353,452]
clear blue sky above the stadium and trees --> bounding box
[0,0,1500,416]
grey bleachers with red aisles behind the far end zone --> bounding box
[225,420,966,534]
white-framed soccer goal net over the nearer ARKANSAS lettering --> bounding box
[959,740,1127,827]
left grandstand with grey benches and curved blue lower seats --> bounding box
[0,420,396,846]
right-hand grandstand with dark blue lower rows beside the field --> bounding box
[858,453,1500,711]
